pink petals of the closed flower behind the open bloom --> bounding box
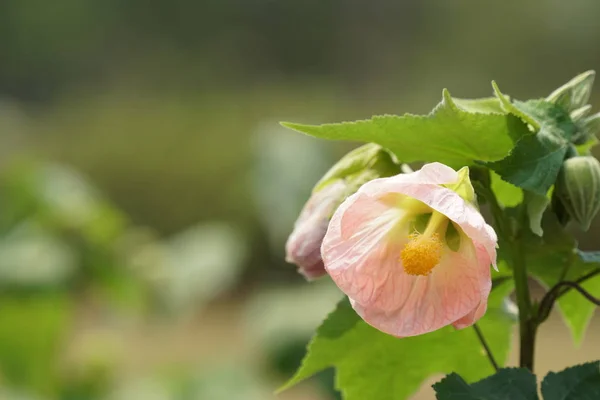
[285,180,347,280]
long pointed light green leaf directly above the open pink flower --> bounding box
[282,90,527,167]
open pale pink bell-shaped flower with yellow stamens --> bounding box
[321,163,497,337]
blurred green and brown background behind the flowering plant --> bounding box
[0,0,600,400]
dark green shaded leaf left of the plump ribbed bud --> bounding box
[487,128,568,196]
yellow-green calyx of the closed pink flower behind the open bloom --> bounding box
[313,143,401,195]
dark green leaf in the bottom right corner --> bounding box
[542,361,600,400]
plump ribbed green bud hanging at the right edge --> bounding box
[555,156,600,230]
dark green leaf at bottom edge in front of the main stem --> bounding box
[433,368,538,400]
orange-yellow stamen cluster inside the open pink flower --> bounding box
[400,233,443,276]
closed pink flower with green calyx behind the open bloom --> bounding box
[286,144,400,280]
